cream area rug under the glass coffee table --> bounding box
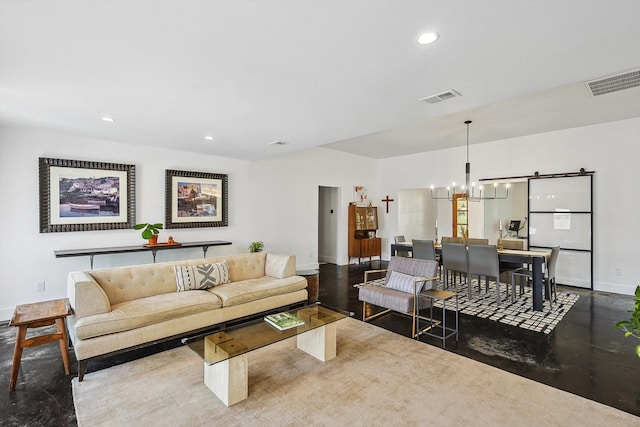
[73,318,640,427]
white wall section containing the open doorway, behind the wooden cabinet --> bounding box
[251,148,384,268]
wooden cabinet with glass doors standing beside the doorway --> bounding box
[349,204,382,262]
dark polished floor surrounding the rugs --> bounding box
[0,261,640,426]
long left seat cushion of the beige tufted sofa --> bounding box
[75,291,222,339]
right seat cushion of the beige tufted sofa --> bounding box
[208,276,307,307]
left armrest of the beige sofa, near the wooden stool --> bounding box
[67,271,111,319]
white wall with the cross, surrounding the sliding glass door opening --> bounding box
[378,118,640,295]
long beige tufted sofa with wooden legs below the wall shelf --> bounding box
[67,252,307,381]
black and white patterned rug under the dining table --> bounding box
[354,279,579,334]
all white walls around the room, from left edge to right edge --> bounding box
[0,118,640,320]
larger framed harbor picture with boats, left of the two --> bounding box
[39,157,135,233]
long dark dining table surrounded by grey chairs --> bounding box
[391,242,551,311]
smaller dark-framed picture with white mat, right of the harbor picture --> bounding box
[165,169,229,228]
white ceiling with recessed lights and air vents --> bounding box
[0,0,640,160]
